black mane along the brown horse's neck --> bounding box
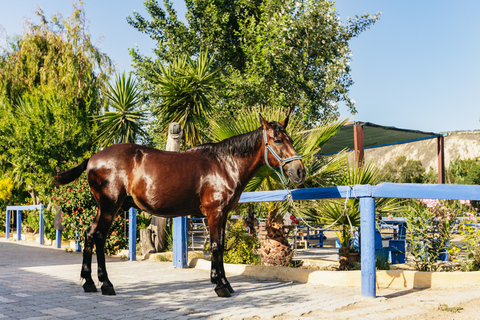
[190,121,285,158]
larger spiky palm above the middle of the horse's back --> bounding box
[153,52,220,146]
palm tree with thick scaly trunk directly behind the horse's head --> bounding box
[210,108,346,265]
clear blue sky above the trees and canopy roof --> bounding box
[0,0,480,132]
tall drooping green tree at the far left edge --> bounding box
[0,5,113,202]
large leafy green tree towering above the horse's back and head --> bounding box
[127,0,379,127]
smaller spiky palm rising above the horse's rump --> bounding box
[94,72,146,148]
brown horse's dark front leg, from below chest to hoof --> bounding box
[208,214,234,297]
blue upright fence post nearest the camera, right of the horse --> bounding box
[360,197,377,298]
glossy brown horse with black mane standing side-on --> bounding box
[56,116,305,297]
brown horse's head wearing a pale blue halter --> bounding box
[260,115,305,185]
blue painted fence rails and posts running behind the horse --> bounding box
[6,183,480,297]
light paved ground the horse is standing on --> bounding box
[0,239,480,320]
